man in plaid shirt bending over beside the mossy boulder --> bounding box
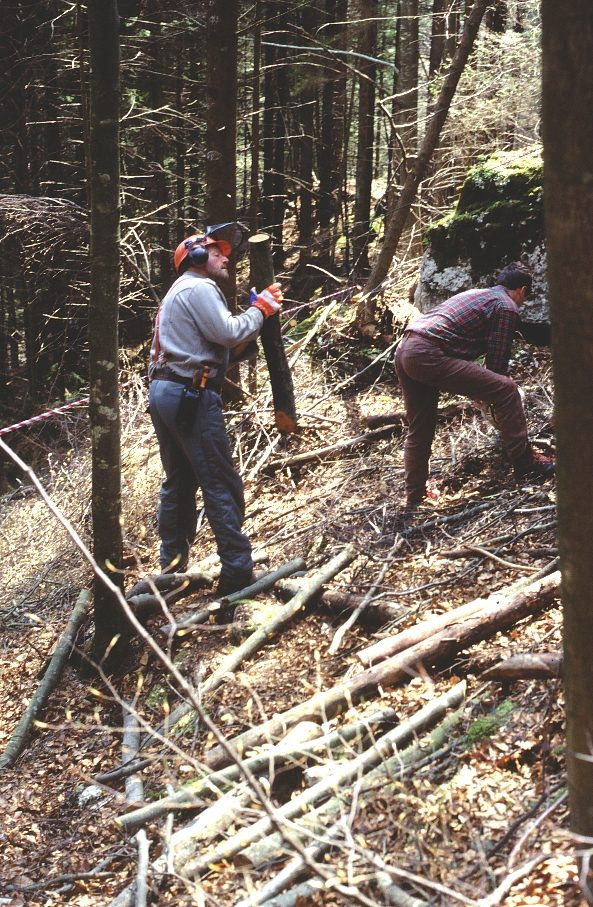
[395,262,554,508]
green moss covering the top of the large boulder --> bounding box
[425,148,544,274]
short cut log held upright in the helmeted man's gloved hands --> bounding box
[249,233,297,434]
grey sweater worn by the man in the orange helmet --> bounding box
[150,271,264,378]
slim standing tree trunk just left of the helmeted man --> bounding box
[88,0,127,664]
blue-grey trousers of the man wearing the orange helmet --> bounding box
[149,380,253,577]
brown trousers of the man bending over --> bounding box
[395,331,528,504]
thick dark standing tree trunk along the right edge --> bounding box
[542,0,593,852]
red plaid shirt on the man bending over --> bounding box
[408,286,520,375]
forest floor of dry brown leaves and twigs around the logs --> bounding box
[0,300,581,907]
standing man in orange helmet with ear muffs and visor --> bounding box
[149,224,282,596]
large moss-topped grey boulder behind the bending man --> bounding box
[414,145,548,321]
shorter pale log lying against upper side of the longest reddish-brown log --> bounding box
[357,572,560,667]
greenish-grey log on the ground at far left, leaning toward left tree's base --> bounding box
[0,589,91,771]
